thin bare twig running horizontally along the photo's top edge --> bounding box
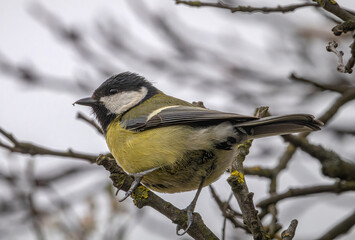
[175,0,319,13]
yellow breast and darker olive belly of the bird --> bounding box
[106,119,234,193]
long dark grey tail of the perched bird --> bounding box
[236,114,323,139]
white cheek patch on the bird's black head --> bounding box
[100,87,148,115]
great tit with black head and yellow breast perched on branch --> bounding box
[75,72,322,233]
